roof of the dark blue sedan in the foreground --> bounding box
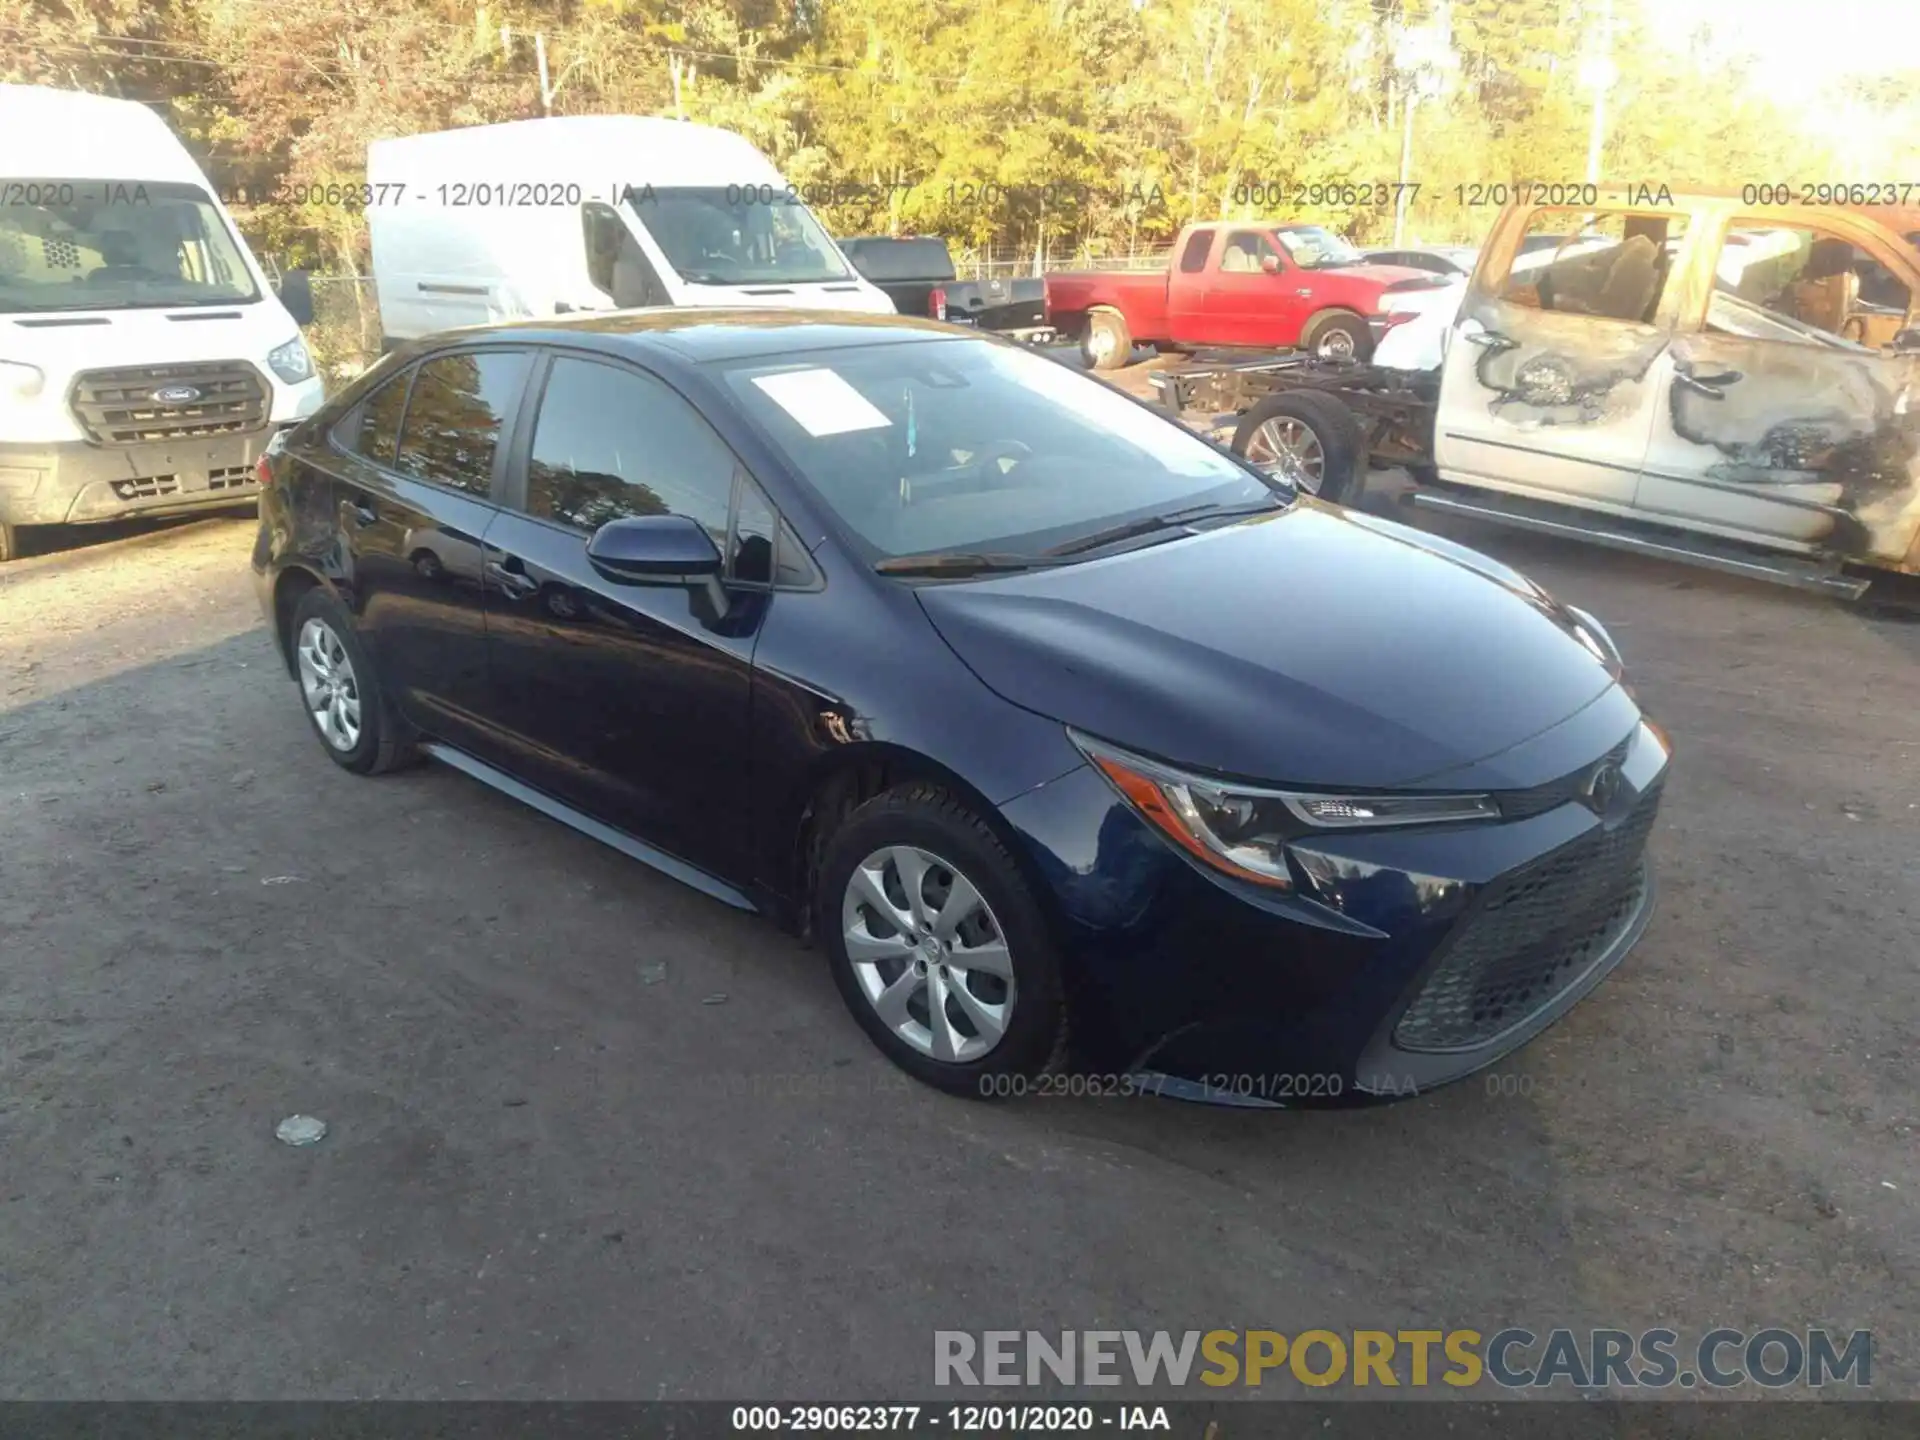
[410,307,979,363]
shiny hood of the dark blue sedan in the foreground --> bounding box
[918,499,1615,787]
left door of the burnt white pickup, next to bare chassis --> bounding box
[1434,207,1688,513]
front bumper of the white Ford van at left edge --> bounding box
[0,426,284,537]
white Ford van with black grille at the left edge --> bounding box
[0,84,321,561]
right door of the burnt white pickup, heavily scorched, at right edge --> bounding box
[1636,215,1920,561]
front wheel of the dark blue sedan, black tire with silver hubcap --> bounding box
[814,783,1066,1098]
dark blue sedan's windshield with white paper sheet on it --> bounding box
[726,338,1284,561]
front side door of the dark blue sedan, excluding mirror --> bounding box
[486,351,772,876]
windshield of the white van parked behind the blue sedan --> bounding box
[626,184,847,284]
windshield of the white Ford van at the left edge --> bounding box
[0,179,259,315]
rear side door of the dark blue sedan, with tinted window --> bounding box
[334,346,532,768]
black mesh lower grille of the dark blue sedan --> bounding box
[1394,785,1661,1050]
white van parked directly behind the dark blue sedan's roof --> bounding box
[367,115,893,344]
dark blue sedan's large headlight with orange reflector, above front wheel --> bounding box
[1068,730,1500,889]
